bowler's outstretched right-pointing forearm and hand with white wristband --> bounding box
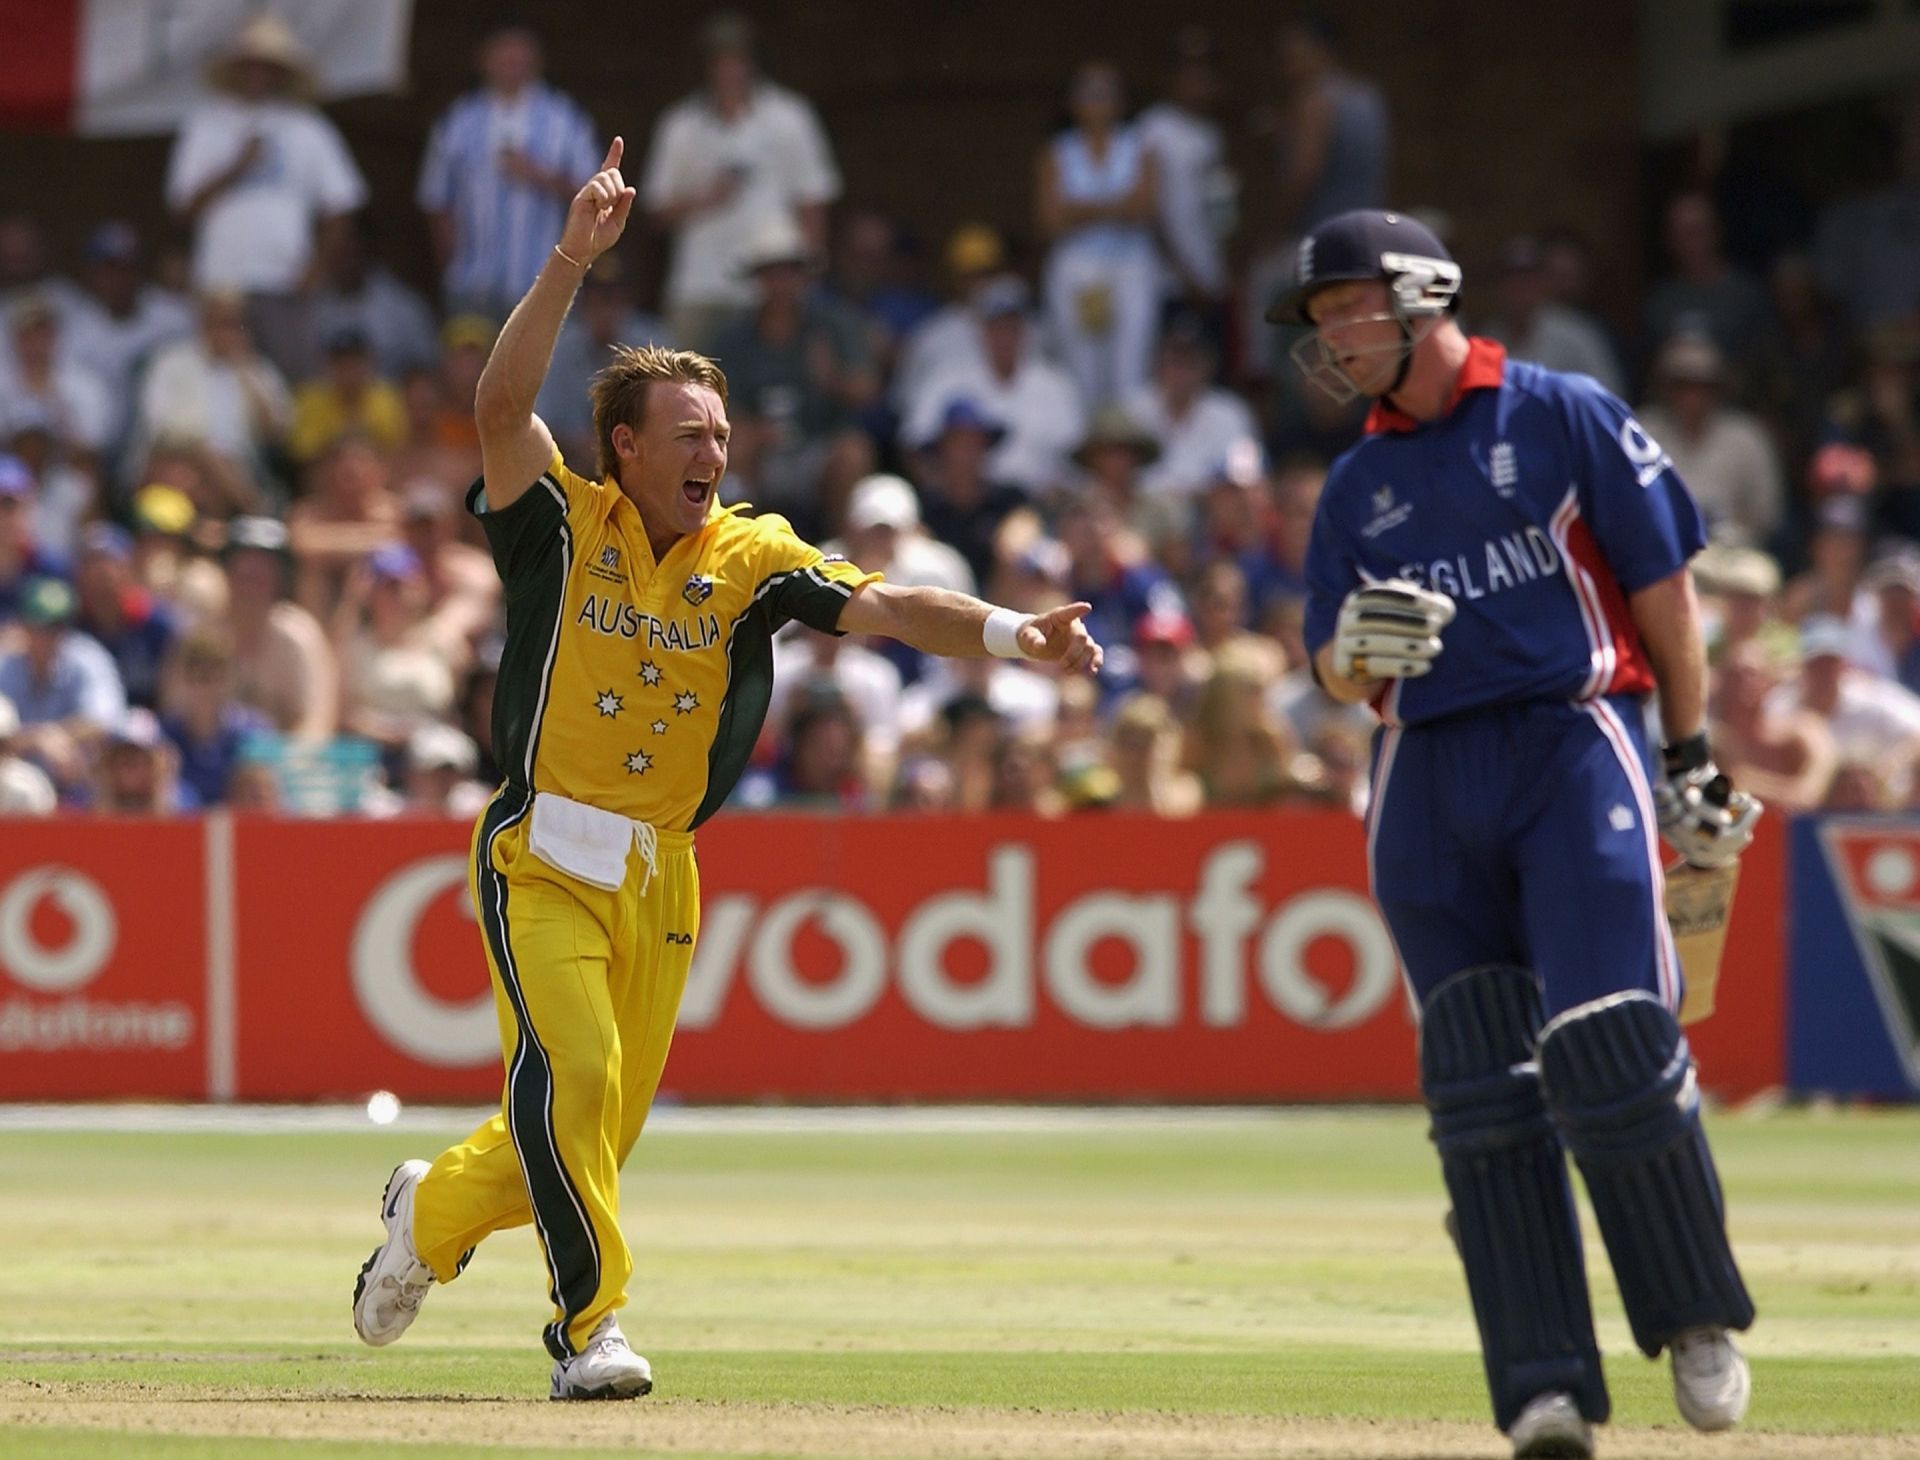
[839,582,1106,674]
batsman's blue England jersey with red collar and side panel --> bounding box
[1306,338,1707,724]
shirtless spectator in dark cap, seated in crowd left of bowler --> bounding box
[227,517,340,740]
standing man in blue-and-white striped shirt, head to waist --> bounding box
[419,25,605,319]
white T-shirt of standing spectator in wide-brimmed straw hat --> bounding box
[167,96,367,294]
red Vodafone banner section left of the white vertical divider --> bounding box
[0,820,207,1101]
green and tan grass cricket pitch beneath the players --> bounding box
[0,1110,1920,1460]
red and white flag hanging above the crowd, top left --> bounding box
[0,0,413,136]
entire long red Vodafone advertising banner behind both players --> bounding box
[0,813,1788,1101]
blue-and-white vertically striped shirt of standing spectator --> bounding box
[419,83,603,307]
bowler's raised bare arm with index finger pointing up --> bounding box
[474,136,634,511]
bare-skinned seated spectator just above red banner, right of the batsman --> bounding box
[1707,640,1837,815]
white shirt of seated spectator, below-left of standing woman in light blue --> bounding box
[900,353,1087,492]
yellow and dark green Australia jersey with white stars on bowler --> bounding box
[467,451,879,832]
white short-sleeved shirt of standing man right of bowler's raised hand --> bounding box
[639,81,841,309]
